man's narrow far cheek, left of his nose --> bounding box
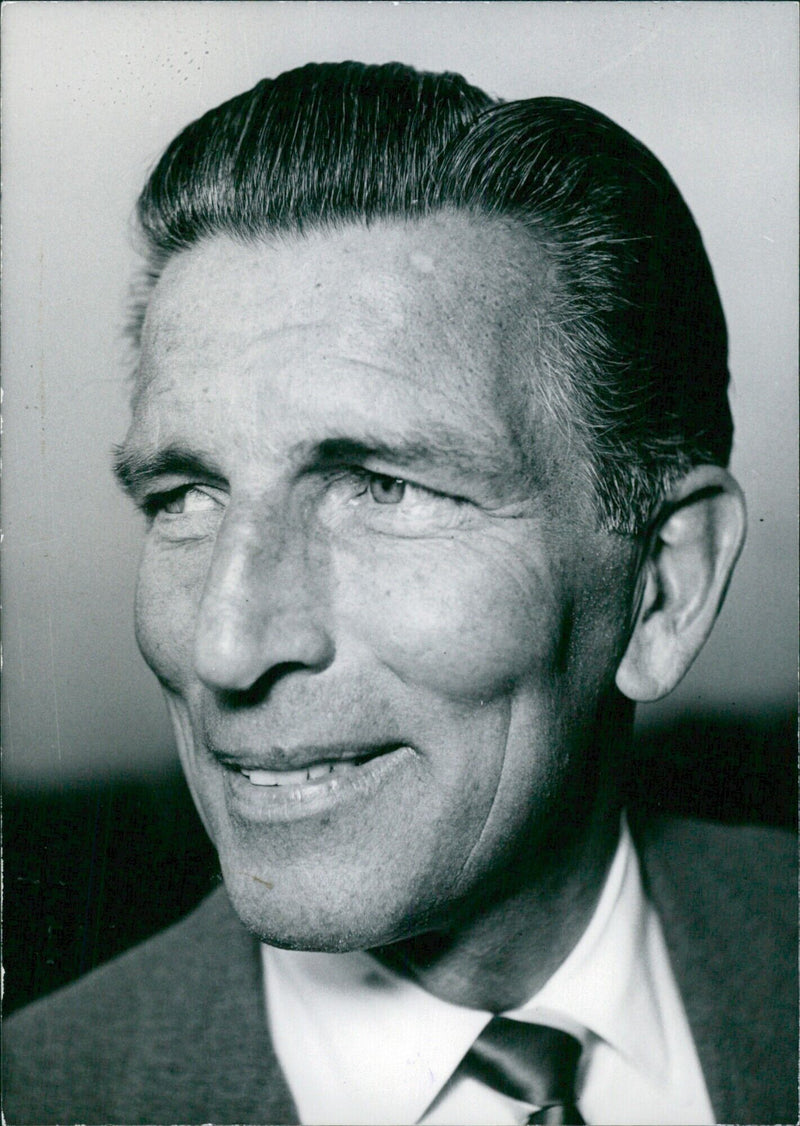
[134,542,208,690]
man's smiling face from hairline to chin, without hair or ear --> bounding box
[126,215,631,949]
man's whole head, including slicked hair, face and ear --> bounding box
[118,63,744,948]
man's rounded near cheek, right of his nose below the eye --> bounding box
[337,542,565,703]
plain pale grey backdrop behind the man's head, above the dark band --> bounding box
[1,0,798,789]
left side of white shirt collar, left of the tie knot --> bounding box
[264,918,490,1124]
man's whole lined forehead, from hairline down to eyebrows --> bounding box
[132,213,570,490]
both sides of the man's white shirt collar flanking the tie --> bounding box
[264,819,707,1124]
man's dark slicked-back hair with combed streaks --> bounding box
[131,62,732,533]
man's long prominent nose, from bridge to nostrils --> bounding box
[195,511,334,691]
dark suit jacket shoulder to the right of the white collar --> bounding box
[631,817,798,1123]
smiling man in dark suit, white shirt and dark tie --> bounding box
[6,63,797,1124]
